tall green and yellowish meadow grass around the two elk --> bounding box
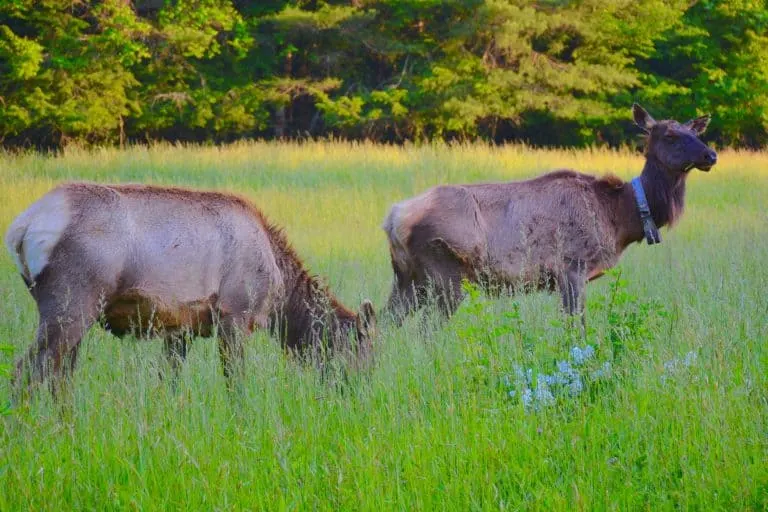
[0,143,768,511]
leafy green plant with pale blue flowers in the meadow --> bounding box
[453,268,668,410]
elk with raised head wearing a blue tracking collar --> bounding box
[383,105,717,328]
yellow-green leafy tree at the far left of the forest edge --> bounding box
[0,0,149,144]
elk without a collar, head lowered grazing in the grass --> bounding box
[6,183,375,391]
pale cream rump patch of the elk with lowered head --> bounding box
[5,190,70,281]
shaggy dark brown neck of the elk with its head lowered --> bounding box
[268,226,357,351]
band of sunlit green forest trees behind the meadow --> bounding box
[0,0,768,148]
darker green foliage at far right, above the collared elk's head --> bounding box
[638,0,768,146]
